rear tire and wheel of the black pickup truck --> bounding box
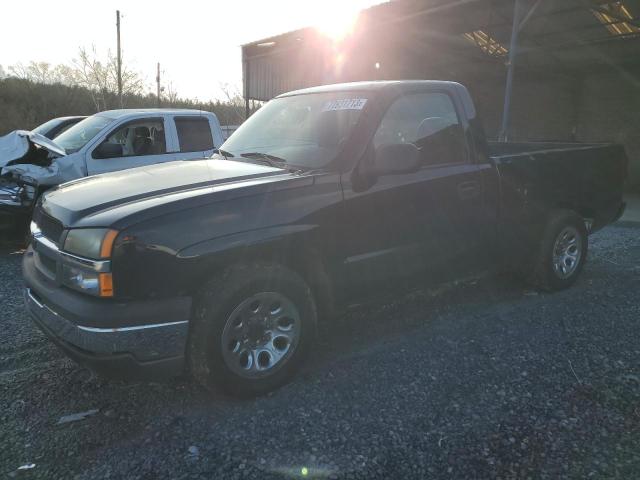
[530,210,589,292]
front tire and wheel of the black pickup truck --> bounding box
[188,263,317,397]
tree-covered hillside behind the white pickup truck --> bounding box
[0,77,249,135]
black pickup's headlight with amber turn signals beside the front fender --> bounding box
[62,228,118,297]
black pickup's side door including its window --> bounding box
[343,91,482,288]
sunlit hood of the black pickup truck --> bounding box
[42,159,293,226]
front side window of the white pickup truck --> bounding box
[93,119,167,158]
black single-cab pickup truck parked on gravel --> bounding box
[23,81,627,395]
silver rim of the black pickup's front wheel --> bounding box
[222,292,301,378]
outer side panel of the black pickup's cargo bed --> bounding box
[489,142,628,234]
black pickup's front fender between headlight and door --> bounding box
[113,175,342,298]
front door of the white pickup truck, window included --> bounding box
[87,117,175,175]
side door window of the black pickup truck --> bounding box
[373,92,468,166]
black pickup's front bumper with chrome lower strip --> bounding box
[23,252,191,378]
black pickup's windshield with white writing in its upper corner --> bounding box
[221,92,367,169]
